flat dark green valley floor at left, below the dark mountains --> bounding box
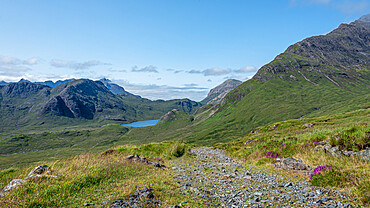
[0,124,129,168]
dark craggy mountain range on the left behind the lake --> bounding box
[0,79,201,132]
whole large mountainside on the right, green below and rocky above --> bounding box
[122,16,370,144]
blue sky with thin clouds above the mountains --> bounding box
[0,0,370,101]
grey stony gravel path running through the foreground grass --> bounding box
[172,147,358,207]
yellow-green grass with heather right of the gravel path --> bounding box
[214,109,370,203]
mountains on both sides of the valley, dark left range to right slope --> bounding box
[0,15,370,150]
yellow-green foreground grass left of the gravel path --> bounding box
[0,142,201,207]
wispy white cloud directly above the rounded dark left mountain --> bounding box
[50,59,111,70]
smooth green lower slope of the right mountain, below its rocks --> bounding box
[110,67,370,145]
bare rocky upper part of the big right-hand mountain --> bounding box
[253,15,370,82]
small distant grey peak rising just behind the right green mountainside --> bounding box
[200,79,242,104]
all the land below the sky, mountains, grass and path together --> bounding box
[0,12,370,207]
